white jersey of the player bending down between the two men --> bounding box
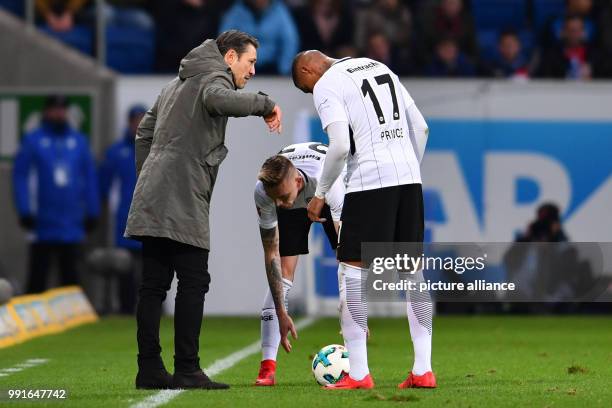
[255,142,345,229]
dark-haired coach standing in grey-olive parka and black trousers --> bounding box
[125,30,281,389]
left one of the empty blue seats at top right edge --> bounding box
[472,0,527,30]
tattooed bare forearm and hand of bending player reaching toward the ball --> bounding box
[259,226,297,352]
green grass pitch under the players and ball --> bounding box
[0,316,612,408]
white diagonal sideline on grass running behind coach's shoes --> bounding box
[131,317,317,408]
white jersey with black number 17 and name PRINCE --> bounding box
[313,58,421,193]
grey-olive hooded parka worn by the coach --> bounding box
[125,40,274,249]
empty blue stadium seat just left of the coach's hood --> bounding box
[106,26,155,74]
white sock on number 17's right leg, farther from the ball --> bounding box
[406,276,433,375]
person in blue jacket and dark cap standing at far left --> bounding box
[13,95,100,293]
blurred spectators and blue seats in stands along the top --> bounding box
[0,0,612,79]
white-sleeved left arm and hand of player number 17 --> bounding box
[308,122,351,222]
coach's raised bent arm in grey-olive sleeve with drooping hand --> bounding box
[202,76,282,131]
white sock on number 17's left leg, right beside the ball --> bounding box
[338,262,370,381]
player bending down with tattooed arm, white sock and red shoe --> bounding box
[255,143,344,386]
